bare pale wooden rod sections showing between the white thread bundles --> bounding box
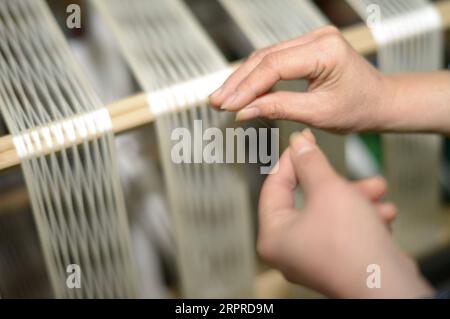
[0,0,450,171]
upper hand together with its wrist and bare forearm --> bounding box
[210,26,450,133]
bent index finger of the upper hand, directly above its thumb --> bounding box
[222,42,325,111]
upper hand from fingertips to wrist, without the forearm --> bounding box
[210,26,394,132]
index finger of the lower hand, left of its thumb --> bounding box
[259,150,297,222]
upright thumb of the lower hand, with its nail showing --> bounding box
[289,129,339,196]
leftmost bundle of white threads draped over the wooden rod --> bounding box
[0,0,136,298]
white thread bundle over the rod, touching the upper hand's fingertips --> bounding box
[93,0,254,298]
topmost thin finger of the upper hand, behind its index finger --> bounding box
[210,25,339,107]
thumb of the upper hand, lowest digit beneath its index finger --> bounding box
[236,91,322,124]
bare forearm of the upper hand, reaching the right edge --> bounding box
[374,71,450,135]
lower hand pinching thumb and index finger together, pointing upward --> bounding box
[258,130,432,298]
